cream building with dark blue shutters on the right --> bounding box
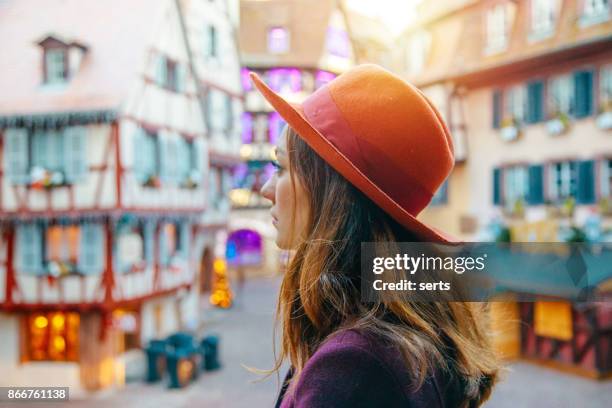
[398,0,612,377]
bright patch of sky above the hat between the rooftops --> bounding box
[345,0,420,34]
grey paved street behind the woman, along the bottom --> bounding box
[8,279,612,408]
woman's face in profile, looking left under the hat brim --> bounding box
[261,132,308,249]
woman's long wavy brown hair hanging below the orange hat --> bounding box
[273,128,498,406]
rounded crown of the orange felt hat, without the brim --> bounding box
[303,64,454,215]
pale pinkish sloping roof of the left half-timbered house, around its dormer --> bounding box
[0,0,170,116]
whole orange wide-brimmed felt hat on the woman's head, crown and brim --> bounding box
[251,64,459,243]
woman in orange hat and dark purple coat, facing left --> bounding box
[251,65,498,408]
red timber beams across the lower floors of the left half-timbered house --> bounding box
[0,118,196,337]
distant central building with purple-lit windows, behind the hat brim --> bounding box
[228,0,355,276]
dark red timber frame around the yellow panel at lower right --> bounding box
[519,302,612,378]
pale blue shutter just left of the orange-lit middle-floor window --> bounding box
[15,223,45,275]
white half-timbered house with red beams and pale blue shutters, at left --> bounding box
[0,0,242,393]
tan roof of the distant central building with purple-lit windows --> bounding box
[239,0,337,67]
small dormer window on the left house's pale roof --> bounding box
[37,35,87,84]
